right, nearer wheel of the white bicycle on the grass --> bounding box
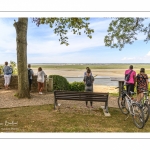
[132,103,145,129]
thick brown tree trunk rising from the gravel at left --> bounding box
[14,18,30,98]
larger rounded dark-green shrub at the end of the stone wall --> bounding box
[49,75,70,90]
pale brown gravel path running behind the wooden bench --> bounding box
[0,89,118,108]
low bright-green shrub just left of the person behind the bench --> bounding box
[70,81,85,91]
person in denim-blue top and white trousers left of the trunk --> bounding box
[3,61,12,90]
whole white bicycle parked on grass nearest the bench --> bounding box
[117,86,145,129]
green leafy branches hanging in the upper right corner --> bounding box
[104,17,150,50]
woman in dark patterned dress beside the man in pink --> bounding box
[136,68,148,102]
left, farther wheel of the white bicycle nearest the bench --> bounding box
[118,96,129,115]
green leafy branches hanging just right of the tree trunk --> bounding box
[33,18,94,46]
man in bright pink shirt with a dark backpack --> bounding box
[125,65,136,96]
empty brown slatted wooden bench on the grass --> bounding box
[54,91,109,113]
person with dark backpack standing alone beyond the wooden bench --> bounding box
[83,68,94,108]
